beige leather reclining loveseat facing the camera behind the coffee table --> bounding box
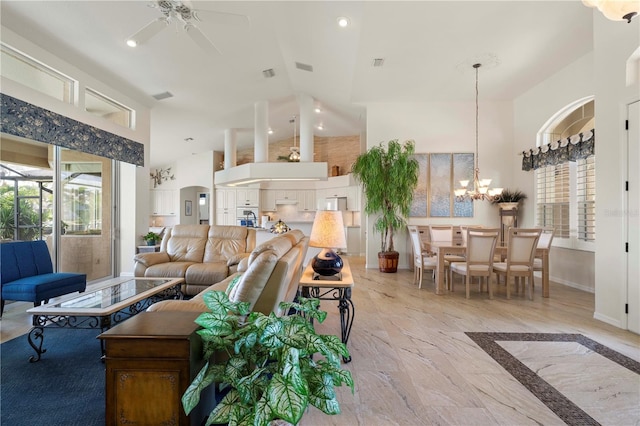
[134,225,256,295]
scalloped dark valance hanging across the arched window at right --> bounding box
[522,129,596,172]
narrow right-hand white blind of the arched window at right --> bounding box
[576,156,596,241]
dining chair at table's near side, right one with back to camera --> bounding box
[493,228,542,300]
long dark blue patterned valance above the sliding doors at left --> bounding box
[0,93,144,166]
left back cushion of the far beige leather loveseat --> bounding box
[162,225,209,263]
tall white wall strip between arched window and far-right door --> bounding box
[594,13,640,328]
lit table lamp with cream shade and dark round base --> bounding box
[309,210,347,276]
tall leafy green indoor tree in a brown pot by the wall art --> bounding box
[351,139,419,272]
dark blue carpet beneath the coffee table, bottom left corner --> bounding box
[0,329,105,426]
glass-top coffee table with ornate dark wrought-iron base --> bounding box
[27,277,184,362]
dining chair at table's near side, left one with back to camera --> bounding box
[449,227,500,299]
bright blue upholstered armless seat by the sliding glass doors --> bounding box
[0,241,87,316]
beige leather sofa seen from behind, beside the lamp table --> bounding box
[148,229,309,315]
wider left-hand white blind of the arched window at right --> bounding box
[535,163,571,238]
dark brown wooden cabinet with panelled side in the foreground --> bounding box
[99,312,215,426]
